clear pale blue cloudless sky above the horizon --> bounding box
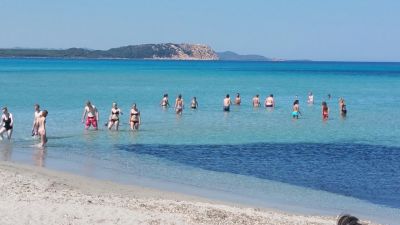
[0,0,400,62]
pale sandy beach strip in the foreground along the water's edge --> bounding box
[0,162,382,225]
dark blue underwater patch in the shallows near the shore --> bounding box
[117,143,400,208]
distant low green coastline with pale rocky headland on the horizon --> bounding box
[0,43,286,61]
